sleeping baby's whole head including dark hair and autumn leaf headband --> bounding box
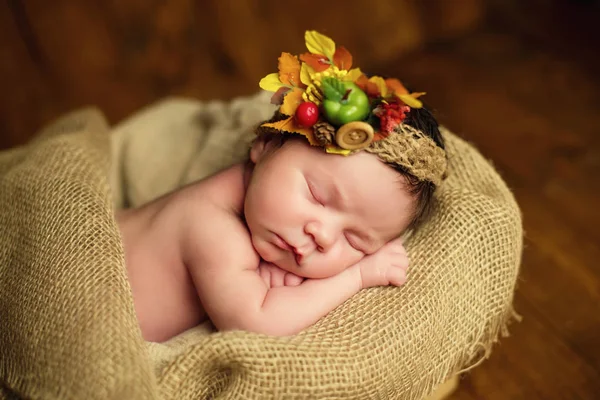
[244,32,446,278]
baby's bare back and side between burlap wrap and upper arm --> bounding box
[117,194,206,342]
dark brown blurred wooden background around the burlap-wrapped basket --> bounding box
[0,0,600,400]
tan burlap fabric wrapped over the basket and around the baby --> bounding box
[0,95,522,400]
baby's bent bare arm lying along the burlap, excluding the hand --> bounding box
[193,236,362,336]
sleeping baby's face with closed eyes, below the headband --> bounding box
[244,139,414,278]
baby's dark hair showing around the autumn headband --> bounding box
[257,107,444,230]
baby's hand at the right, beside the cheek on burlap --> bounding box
[355,238,408,289]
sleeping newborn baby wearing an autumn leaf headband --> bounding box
[117,32,445,342]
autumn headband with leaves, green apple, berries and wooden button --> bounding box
[257,31,446,185]
